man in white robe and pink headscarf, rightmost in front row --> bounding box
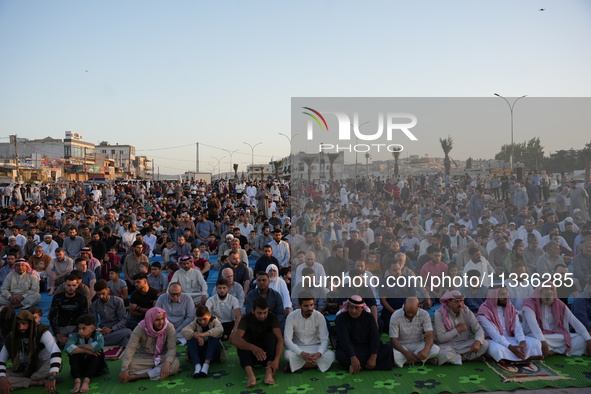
[523,286,591,357]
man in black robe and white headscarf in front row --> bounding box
[335,295,393,373]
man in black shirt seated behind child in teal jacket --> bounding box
[49,274,88,347]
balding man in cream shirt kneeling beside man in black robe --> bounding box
[390,297,439,368]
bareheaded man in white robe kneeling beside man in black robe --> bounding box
[284,293,335,372]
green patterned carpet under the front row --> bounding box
[19,347,591,394]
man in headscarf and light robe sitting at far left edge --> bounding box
[0,259,41,309]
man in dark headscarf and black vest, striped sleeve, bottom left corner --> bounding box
[0,311,62,393]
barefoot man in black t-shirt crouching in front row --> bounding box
[230,297,283,387]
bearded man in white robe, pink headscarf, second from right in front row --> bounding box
[477,287,542,362]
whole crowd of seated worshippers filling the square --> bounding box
[0,173,591,393]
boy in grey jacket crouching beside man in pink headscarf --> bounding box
[181,305,226,378]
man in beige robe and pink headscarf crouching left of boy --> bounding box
[119,307,180,383]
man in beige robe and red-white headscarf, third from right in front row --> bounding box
[435,290,488,365]
